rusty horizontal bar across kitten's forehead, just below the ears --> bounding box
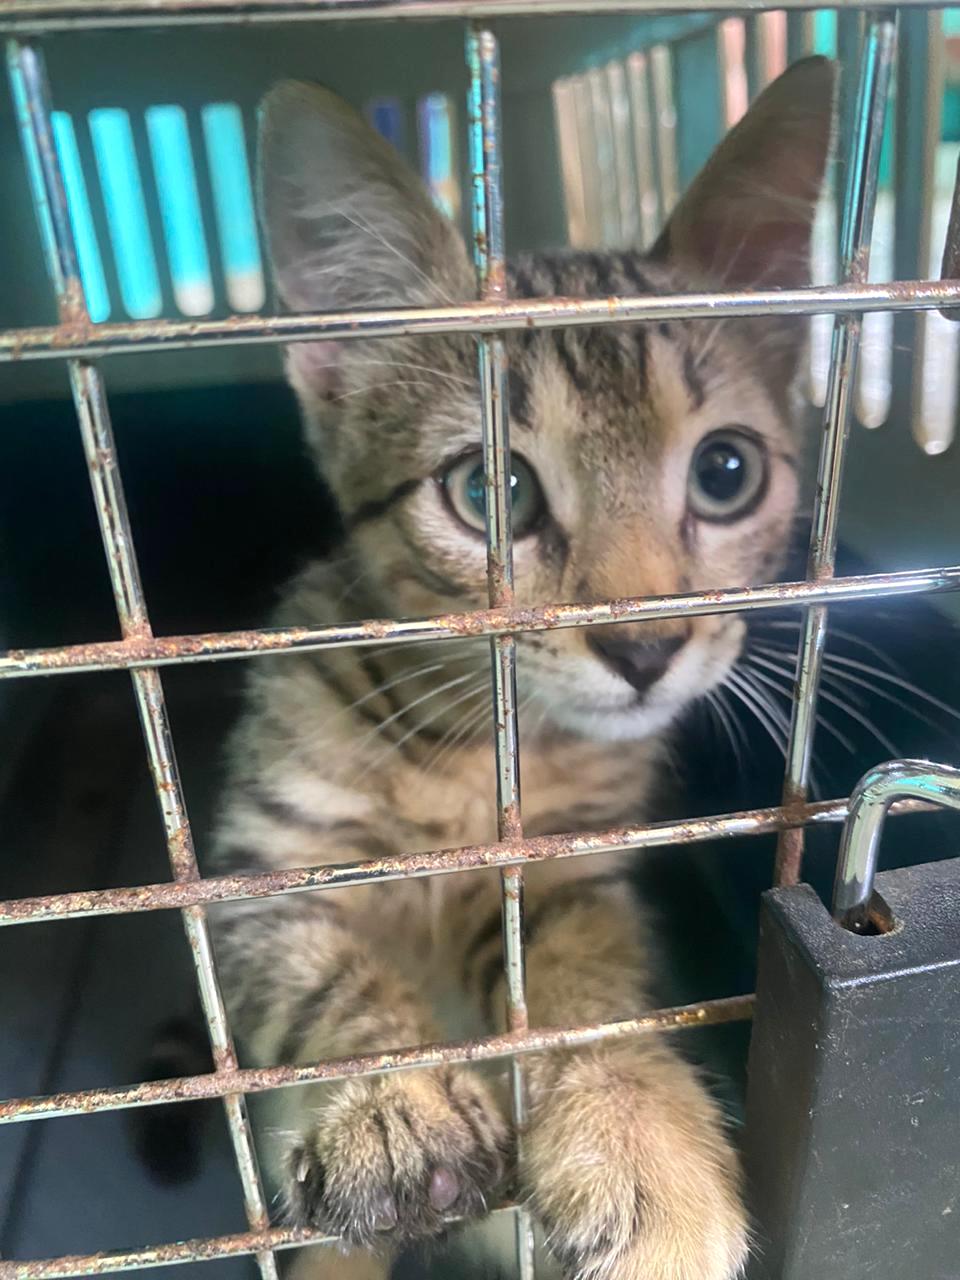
[0,279,960,362]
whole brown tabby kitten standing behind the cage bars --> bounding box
[208,59,835,1280]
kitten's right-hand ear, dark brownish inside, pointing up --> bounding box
[650,58,837,288]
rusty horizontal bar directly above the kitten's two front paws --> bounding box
[0,995,754,1126]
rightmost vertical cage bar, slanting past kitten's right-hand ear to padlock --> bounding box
[776,14,896,884]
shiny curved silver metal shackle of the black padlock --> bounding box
[833,760,960,933]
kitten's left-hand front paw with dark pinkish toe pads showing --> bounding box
[287,1070,507,1245]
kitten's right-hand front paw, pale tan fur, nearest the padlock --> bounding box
[525,1047,748,1280]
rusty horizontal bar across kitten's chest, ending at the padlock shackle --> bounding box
[0,799,942,927]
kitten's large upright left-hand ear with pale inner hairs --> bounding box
[259,81,474,311]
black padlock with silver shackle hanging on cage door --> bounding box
[745,760,960,1280]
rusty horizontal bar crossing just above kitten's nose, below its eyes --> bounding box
[0,564,960,680]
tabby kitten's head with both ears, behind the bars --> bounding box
[261,60,832,739]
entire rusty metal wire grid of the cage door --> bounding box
[0,0,960,1280]
